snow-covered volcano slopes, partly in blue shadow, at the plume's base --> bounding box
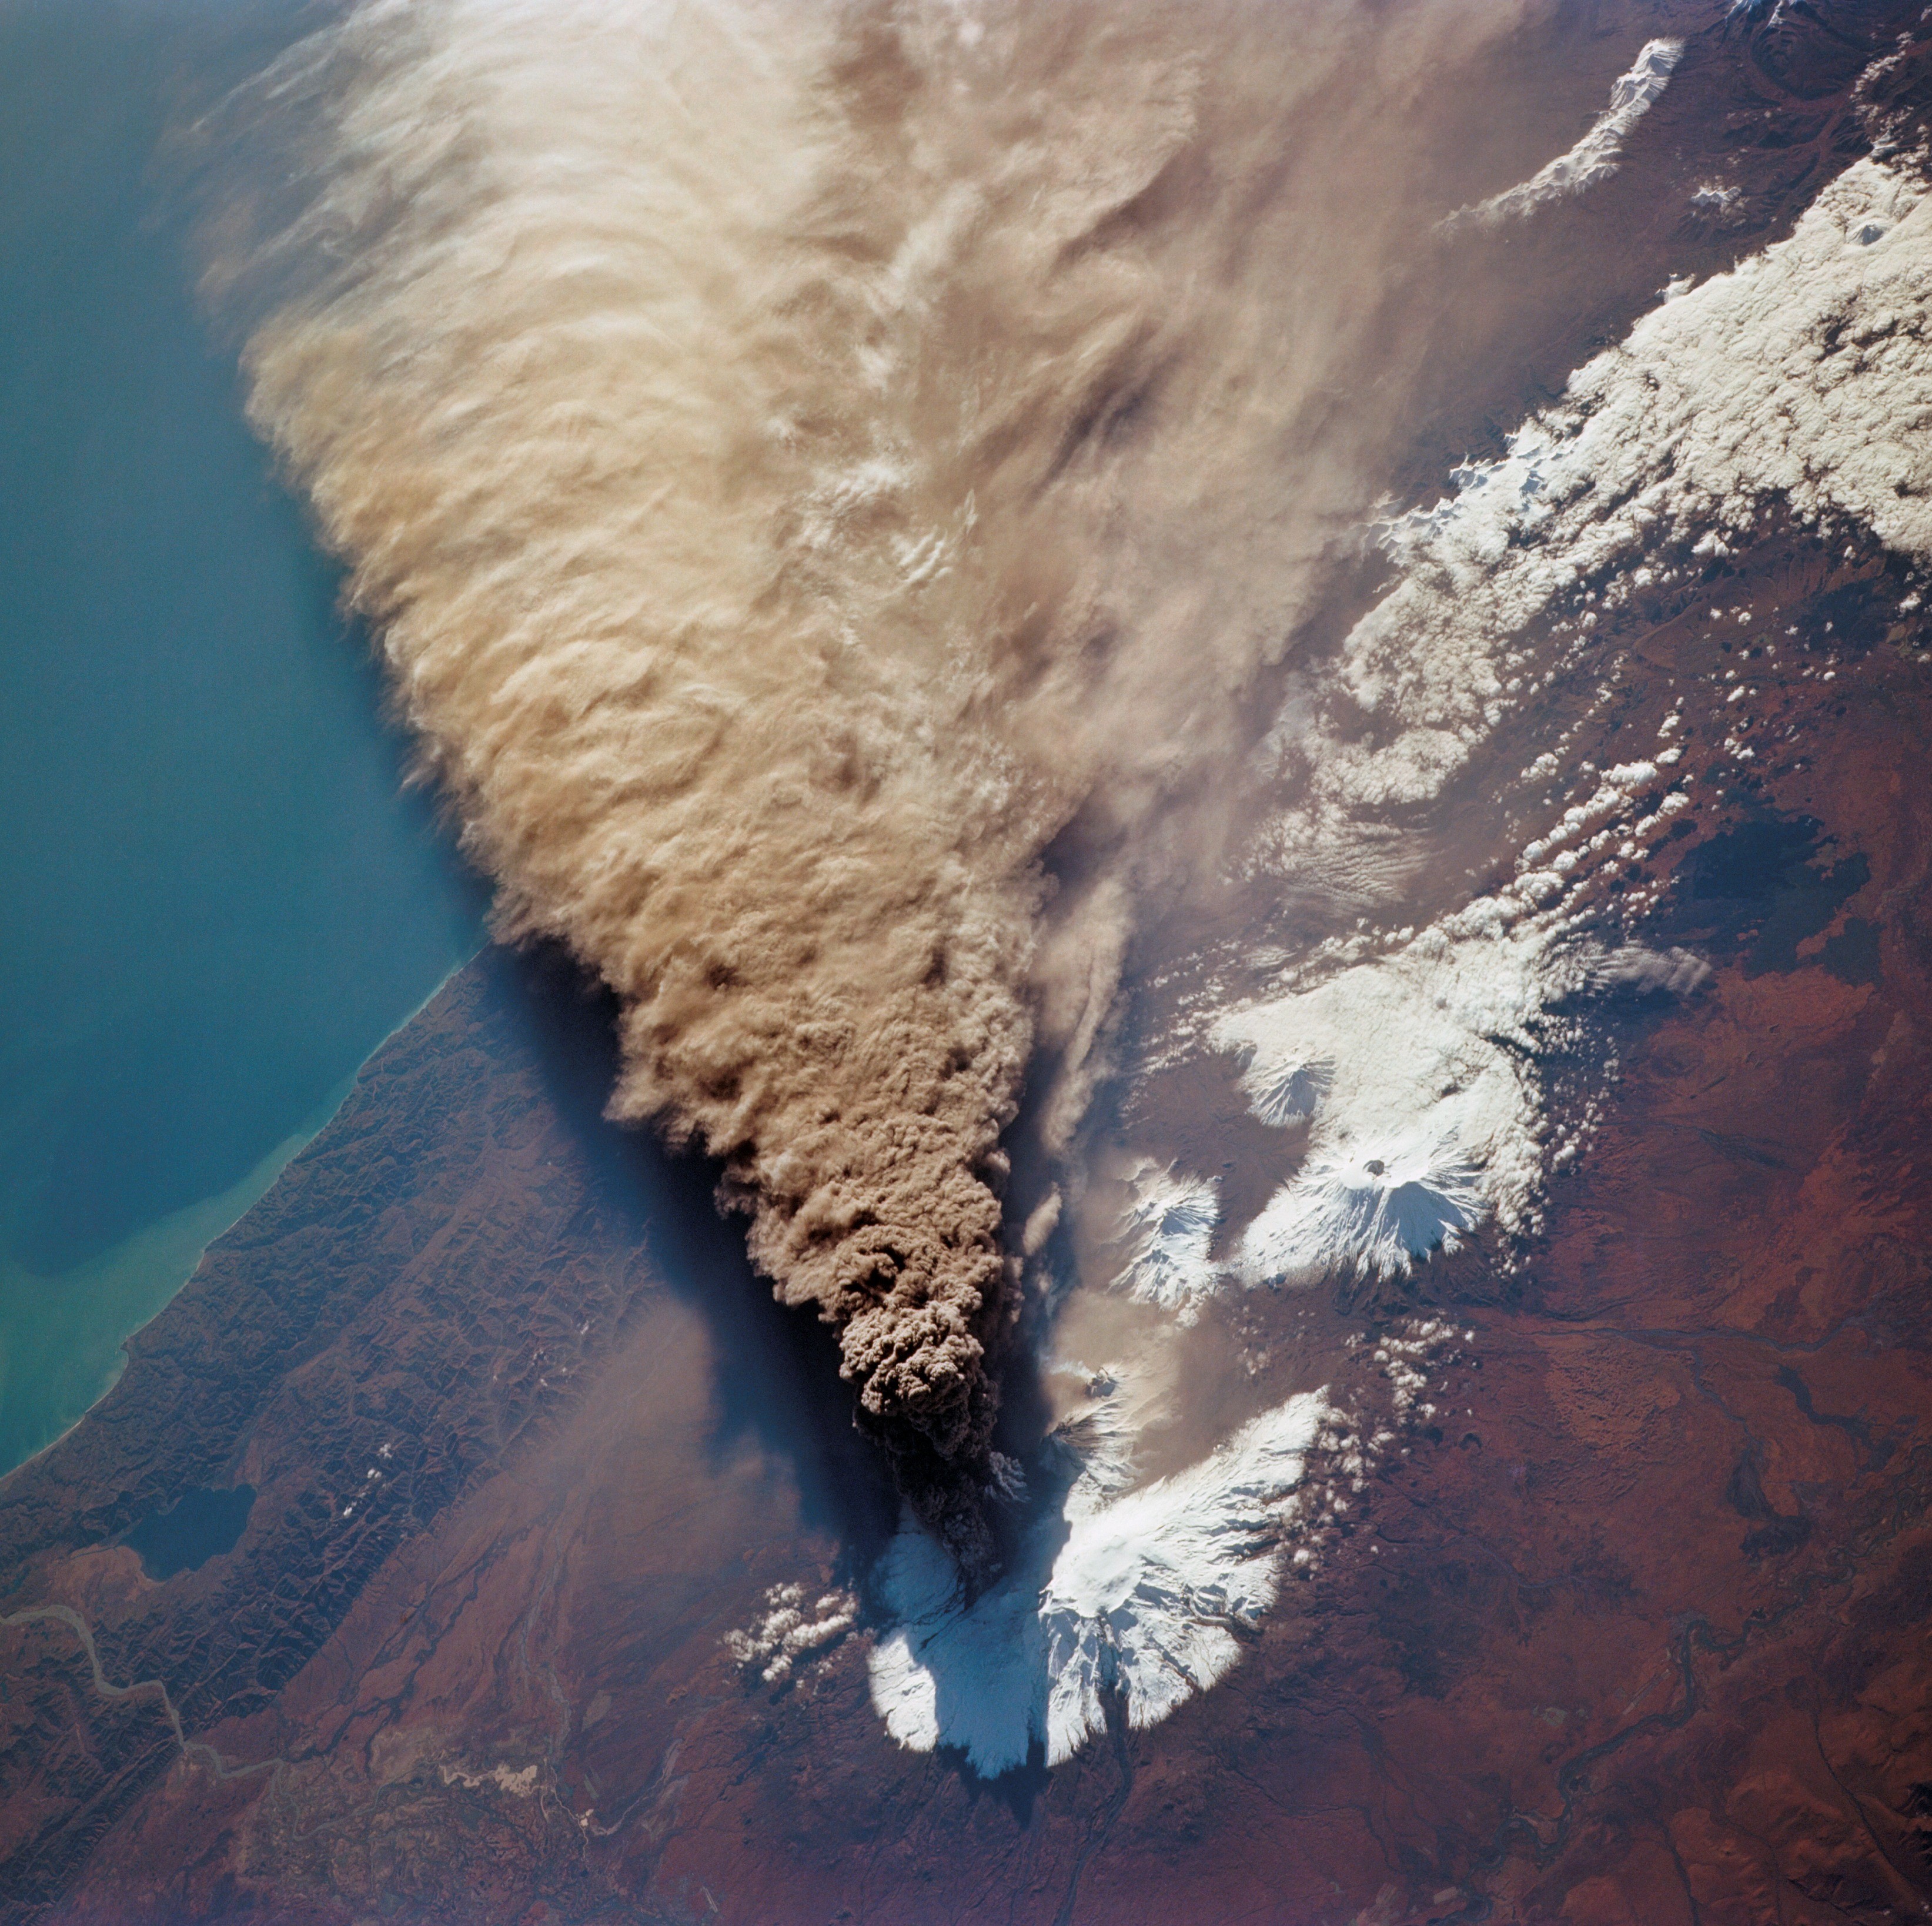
[871,1379,1327,1773]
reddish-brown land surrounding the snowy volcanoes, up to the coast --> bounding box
[0,6,1932,1926]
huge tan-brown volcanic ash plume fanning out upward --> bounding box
[203,0,1537,1567]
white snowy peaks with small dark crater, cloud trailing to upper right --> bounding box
[1208,730,1706,1285]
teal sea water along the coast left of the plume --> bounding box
[0,0,481,1466]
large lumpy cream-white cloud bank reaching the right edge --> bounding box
[1248,160,1932,900]
